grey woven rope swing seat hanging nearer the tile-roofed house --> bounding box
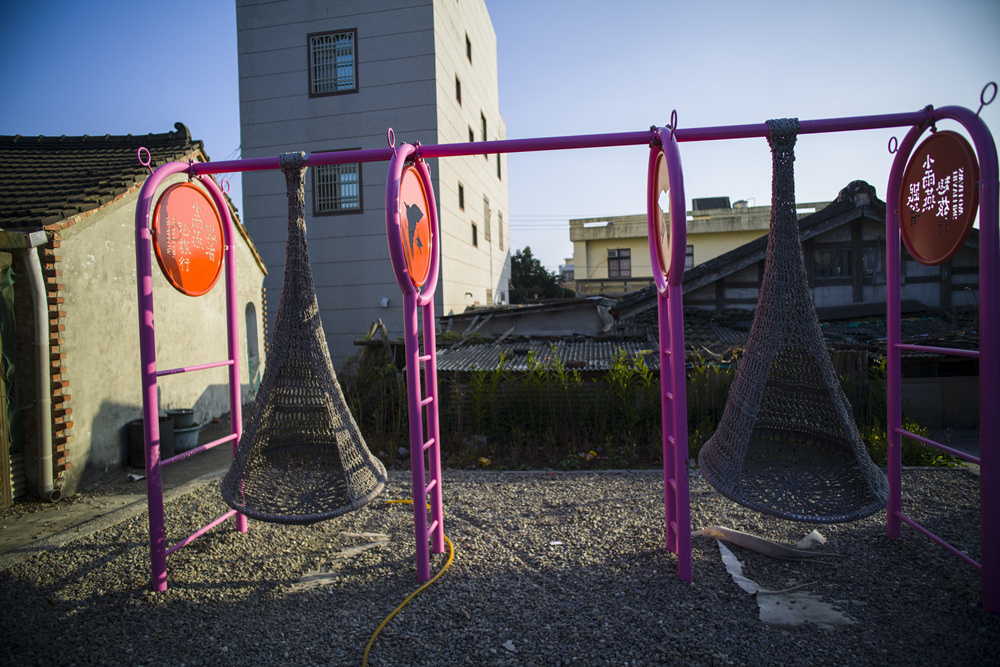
[222,153,387,524]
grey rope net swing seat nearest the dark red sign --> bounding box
[698,119,889,523]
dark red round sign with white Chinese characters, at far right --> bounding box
[899,131,979,266]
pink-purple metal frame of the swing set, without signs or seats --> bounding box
[136,107,1000,613]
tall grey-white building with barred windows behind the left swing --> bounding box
[236,0,510,364]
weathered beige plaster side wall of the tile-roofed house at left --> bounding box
[53,175,264,494]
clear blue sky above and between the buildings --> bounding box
[0,0,1000,270]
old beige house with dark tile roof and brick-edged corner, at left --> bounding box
[0,123,266,502]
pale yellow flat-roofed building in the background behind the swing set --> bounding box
[569,197,826,296]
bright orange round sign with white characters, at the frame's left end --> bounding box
[153,183,224,296]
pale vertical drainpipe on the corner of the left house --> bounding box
[24,232,62,503]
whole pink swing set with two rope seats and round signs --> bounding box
[135,88,1000,613]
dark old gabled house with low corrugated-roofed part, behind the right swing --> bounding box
[422,181,979,428]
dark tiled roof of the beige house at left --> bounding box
[0,123,207,229]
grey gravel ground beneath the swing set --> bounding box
[0,470,1000,666]
